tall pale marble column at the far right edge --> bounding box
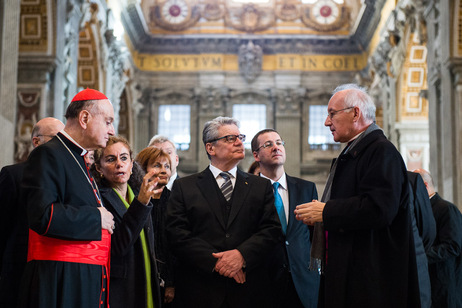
[425,0,461,204]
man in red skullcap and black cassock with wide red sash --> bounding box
[19,89,114,308]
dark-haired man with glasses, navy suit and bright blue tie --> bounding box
[251,129,319,308]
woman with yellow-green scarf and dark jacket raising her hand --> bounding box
[92,137,162,308]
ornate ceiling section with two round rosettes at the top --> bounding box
[140,0,351,33]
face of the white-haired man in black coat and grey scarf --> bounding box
[324,90,355,143]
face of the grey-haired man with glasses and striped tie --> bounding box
[210,125,245,165]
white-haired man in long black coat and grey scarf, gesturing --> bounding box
[296,84,421,308]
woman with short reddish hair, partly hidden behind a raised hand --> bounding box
[135,147,175,304]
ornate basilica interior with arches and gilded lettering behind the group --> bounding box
[0,0,462,204]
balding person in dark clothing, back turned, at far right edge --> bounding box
[414,169,462,308]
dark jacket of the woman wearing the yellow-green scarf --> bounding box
[100,187,161,308]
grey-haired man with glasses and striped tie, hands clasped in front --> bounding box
[167,117,281,308]
